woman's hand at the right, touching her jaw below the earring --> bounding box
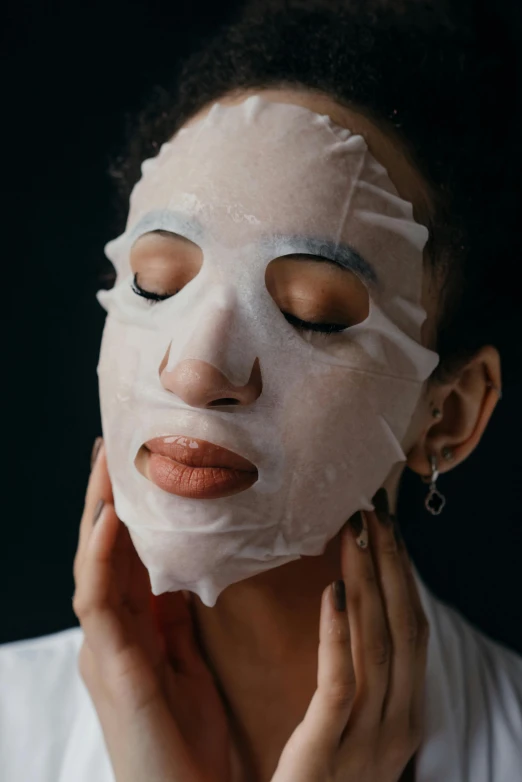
[272,489,429,782]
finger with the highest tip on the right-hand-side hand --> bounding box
[367,489,417,728]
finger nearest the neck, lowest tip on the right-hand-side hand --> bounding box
[294,581,356,757]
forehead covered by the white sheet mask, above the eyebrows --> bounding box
[128,95,427,284]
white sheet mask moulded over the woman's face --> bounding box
[98,95,438,606]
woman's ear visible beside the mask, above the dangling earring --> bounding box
[407,345,501,476]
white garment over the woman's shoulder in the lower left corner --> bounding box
[0,627,111,782]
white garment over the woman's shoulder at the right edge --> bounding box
[410,573,522,782]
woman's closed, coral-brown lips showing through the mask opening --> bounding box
[136,435,258,499]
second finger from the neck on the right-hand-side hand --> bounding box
[341,511,391,740]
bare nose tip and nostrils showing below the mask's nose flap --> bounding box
[159,345,263,407]
